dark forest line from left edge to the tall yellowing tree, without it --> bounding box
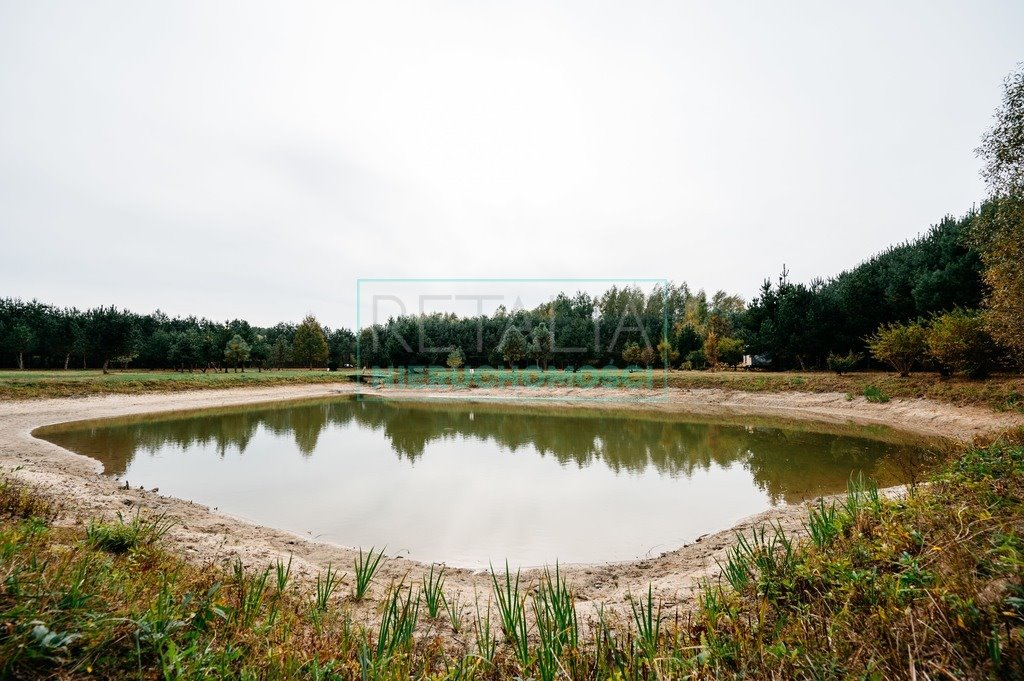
[0,213,983,371]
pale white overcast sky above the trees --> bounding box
[0,0,1024,326]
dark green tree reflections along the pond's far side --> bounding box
[42,398,921,503]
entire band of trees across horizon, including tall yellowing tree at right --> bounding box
[6,71,1024,376]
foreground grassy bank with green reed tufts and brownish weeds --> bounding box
[0,443,1024,679]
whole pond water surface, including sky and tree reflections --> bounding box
[37,397,937,567]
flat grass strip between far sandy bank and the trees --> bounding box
[0,369,1024,412]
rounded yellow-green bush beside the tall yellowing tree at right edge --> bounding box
[927,307,995,378]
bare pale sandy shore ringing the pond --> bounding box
[0,384,1024,619]
